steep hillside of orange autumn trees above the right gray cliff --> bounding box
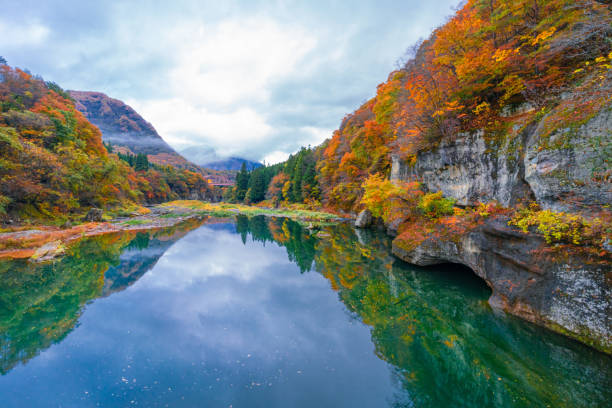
[318,0,612,211]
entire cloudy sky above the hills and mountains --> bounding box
[0,0,458,162]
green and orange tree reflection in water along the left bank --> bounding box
[0,221,206,374]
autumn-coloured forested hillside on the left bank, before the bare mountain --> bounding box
[0,63,213,219]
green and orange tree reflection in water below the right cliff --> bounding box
[237,217,612,407]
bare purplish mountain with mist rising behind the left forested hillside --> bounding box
[68,91,233,184]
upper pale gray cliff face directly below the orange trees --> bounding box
[391,108,612,212]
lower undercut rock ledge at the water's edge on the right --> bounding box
[392,219,612,353]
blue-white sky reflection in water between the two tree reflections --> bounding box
[0,226,397,407]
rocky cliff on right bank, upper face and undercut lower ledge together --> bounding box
[390,90,612,353]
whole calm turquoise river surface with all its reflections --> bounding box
[0,217,612,407]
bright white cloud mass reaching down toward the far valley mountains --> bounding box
[128,18,317,158]
